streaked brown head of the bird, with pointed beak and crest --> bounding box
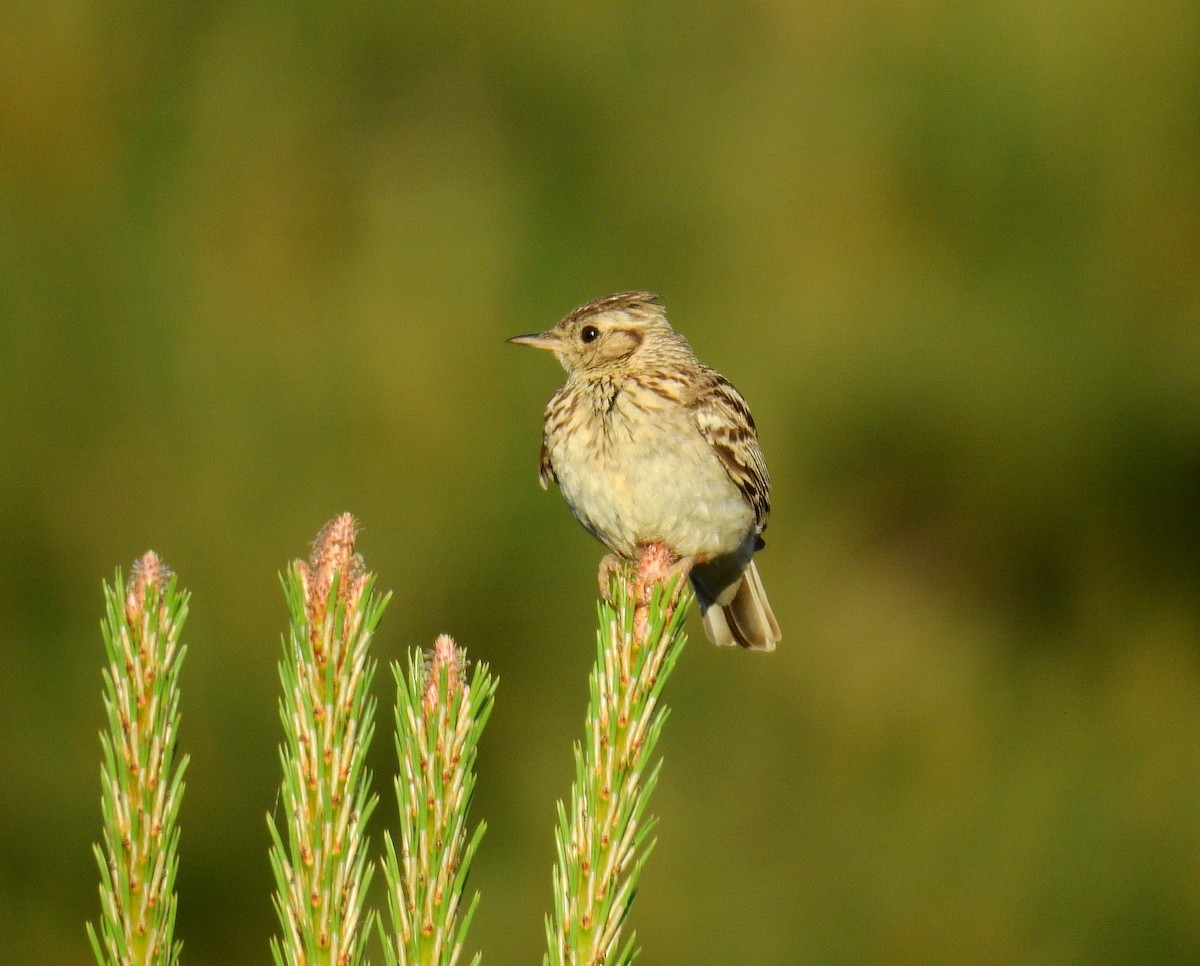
[509,292,690,376]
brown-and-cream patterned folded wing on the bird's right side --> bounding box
[688,370,770,533]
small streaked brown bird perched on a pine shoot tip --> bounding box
[509,292,780,650]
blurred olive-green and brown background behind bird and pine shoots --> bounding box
[7,0,1200,966]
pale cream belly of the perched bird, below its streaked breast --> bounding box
[551,405,754,558]
